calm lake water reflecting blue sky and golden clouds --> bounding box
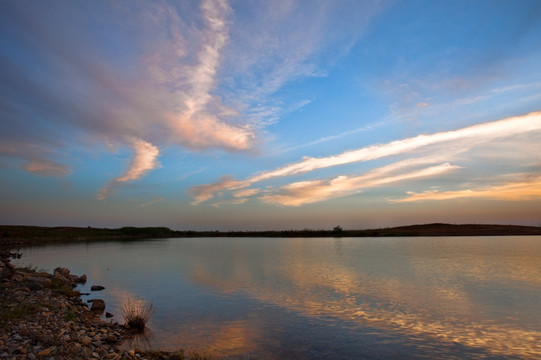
[13,236,541,359]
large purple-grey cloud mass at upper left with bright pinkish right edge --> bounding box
[0,0,256,186]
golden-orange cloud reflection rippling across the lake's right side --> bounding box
[180,238,541,358]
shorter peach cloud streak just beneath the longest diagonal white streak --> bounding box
[260,163,460,206]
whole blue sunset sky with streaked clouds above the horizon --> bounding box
[0,0,541,231]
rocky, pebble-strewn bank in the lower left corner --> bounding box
[0,251,198,360]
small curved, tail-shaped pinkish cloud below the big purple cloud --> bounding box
[97,139,160,200]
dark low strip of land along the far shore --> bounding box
[0,223,541,247]
